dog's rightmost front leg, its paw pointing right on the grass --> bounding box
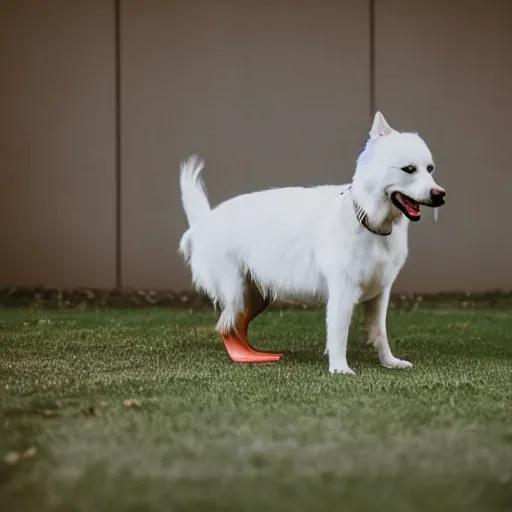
[363,287,412,368]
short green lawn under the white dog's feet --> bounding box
[0,309,512,512]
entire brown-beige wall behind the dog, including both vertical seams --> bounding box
[0,0,512,293]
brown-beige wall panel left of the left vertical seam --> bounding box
[0,0,116,287]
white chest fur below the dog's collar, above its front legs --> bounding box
[353,226,408,302]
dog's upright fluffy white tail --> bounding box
[180,155,211,227]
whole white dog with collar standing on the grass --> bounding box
[180,112,445,373]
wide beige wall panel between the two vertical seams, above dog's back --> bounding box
[121,0,370,288]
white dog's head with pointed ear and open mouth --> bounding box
[356,112,446,221]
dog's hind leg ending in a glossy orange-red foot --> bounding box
[219,279,283,363]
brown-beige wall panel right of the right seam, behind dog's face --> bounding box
[375,0,512,292]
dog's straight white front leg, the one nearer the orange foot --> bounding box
[327,288,356,374]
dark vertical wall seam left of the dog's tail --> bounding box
[114,0,122,288]
